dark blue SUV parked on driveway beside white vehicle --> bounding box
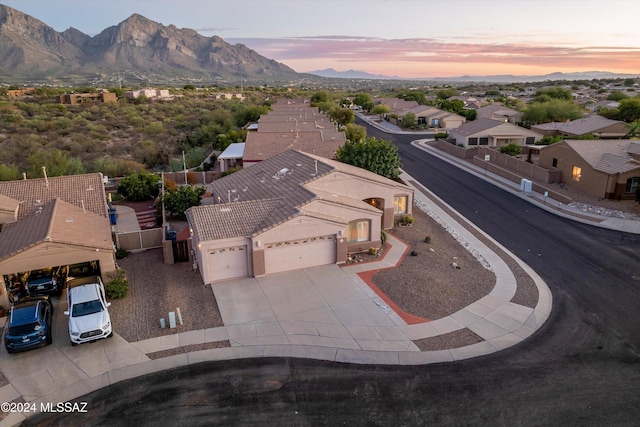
[4,295,53,353]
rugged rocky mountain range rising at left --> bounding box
[0,4,301,84]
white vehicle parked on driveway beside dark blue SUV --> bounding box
[64,276,113,345]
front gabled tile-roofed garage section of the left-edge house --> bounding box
[0,199,115,306]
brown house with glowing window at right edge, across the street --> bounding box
[538,139,640,200]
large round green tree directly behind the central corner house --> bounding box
[336,137,402,179]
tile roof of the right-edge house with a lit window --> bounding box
[564,139,640,174]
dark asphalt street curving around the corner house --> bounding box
[25,121,640,426]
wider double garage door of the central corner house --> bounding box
[264,236,336,274]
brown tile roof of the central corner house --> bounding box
[192,150,405,241]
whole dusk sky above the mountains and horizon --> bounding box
[5,0,640,78]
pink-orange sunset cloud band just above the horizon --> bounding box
[230,36,640,75]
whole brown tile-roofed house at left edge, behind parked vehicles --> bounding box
[0,173,115,306]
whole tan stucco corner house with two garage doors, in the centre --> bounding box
[187,150,413,283]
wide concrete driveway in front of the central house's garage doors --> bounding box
[212,265,419,351]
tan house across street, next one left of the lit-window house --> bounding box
[447,119,542,147]
